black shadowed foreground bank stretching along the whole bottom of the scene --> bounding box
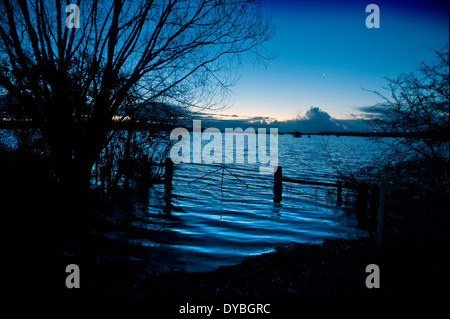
[0,158,450,302]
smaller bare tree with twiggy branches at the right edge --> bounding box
[365,45,449,192]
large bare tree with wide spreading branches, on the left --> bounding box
[0,0,272,191]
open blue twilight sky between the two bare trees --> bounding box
[212,0,449,120]
